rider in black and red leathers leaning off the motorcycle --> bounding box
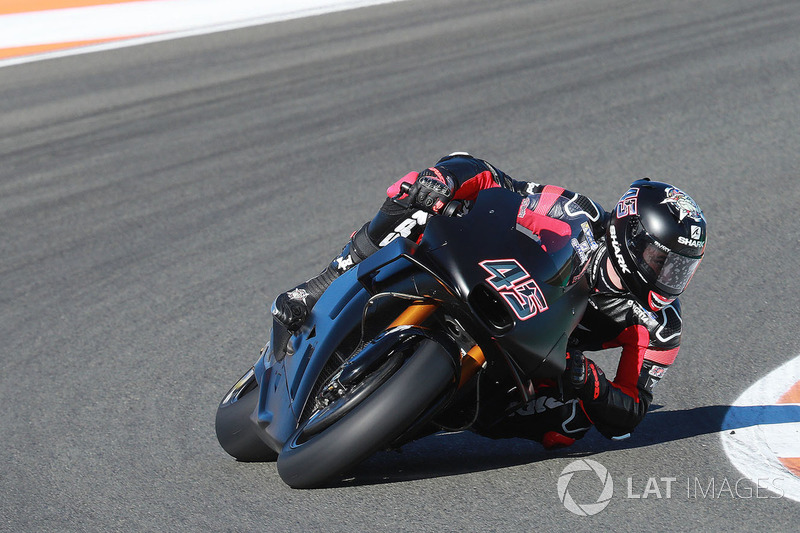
[272,152,706,449]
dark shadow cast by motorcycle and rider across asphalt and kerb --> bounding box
[328,404,800,487]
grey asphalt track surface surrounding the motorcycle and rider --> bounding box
[0,0,800,531]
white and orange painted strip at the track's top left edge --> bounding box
[0,0,399,67]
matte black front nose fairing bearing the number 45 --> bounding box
[416,189,589,377]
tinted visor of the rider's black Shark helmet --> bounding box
[629,225,702,295]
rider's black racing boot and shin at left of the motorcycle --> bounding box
[272,223,378,333]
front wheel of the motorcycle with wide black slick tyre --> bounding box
[278,339,455,488]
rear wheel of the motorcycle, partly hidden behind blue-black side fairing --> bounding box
[215,368,278,461]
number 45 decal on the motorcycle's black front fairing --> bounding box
[478,259,548,320]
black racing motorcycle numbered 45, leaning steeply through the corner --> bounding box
[216,184,597,488]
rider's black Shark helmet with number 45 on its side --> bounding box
[606,178,706,311]
